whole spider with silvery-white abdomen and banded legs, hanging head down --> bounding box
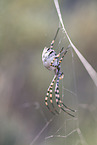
[42,28,75,117]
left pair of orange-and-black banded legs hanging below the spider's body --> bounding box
[45,75,59,115]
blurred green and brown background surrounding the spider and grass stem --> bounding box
[0,0,97,145]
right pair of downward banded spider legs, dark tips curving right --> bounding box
[55,75,75,117]
